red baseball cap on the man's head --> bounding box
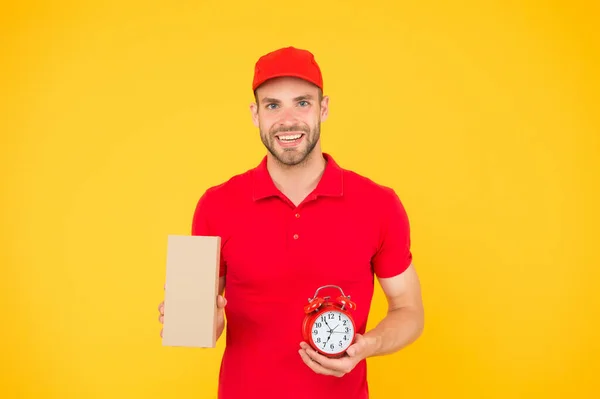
[252,47,323,91]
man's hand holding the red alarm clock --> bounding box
[299,334,377,377]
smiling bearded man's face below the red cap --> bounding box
[251,77,328,166]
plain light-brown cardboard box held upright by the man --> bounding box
[162,235,221,348]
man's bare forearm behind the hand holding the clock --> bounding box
[364,307,424,357]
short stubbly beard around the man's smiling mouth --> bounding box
[260,122,321,166]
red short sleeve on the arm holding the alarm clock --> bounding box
[372,189,412,278]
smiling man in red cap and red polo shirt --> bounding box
[159,47,423,399]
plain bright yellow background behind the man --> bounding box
[0,1,600,399]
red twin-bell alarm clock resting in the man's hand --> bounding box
[302,285,356,358]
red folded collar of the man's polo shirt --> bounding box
[252,153,344,201]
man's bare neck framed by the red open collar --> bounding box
[267,149,327,205]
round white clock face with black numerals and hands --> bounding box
[311,310,354,354]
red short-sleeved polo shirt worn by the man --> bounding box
[192,154,411,399]
